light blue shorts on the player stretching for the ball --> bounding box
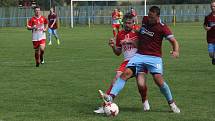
[127,53,163,74]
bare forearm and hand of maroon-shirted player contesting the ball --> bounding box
[168,37,179,58]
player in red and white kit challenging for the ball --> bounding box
[94,14,150,113]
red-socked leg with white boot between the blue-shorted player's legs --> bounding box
[136,72,150,111]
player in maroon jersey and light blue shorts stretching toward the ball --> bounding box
[102,6,180,113]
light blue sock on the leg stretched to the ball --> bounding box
[110,78,126,96]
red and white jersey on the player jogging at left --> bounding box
[27,16,48,41]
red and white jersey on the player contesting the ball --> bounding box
[116,30,138,61]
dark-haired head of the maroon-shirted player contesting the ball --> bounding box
[148,6,160,24]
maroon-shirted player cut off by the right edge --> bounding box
[204,0,215,65]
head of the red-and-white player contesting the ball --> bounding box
[123,13,134,31]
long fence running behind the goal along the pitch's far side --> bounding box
[0,4,211,27]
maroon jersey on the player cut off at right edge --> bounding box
[204,13,215,43]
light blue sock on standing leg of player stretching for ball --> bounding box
[160,82,173,102]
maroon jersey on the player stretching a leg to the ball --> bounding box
[137,17,173,57]
